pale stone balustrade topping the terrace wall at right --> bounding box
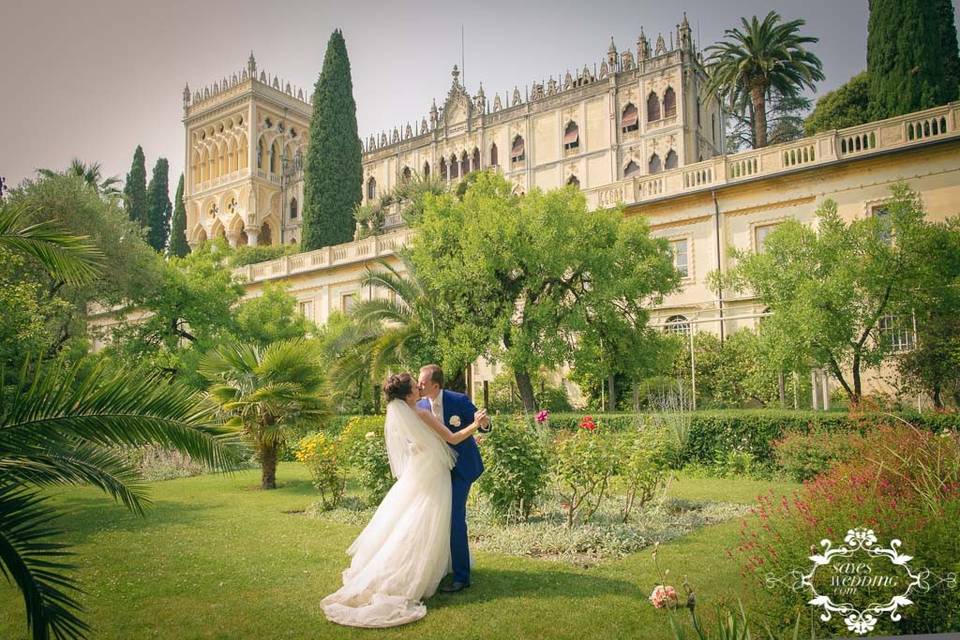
[584,102,960,209]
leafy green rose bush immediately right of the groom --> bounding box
[477,417,549,520]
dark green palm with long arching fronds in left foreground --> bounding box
[0,361,240,640]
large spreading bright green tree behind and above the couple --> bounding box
[411,172,679,411]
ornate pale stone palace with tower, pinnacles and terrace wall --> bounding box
[91,19,960,404]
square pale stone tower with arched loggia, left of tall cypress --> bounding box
[183,53,312,246]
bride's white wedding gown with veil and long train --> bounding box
[322,400,456,627]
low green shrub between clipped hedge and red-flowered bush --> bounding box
[773,430,862,482]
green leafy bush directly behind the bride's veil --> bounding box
[340,416,394,504]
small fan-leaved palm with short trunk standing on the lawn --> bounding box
[197,338,326,489]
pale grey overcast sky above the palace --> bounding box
[0,0,960,192]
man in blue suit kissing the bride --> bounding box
[417,364,490,593]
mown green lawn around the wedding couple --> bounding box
[0,463,793,640]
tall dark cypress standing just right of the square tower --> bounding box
[301,29,363,251]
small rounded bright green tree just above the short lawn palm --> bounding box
[233,283,316,347]
